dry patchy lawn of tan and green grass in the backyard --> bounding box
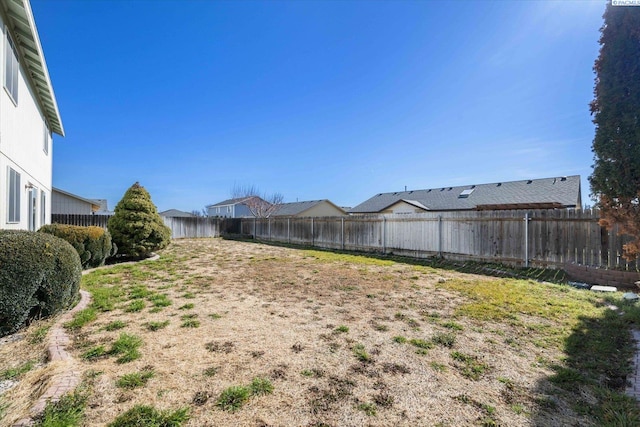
[0,239,637,427]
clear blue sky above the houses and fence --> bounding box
[31,0,605,211]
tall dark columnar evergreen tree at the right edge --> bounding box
[589,3,640,259]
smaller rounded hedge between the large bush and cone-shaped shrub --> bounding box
[38,224,116,269]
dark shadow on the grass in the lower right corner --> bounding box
[531,297,640,427]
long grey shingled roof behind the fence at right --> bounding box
[349,175,581,213]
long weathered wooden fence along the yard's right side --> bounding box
[242,210,638,269]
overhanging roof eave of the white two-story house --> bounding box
[2,0,64,136]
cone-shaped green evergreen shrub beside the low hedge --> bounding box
[108,182,171,257]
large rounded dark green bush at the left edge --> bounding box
[0,231,82,336]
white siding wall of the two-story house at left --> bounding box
[0,8,53,230]
